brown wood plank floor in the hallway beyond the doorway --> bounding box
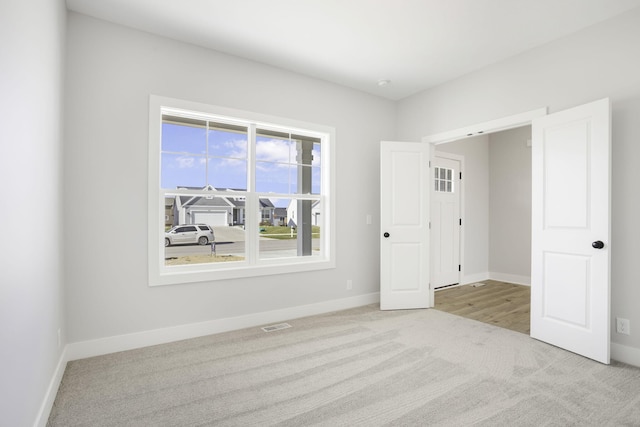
[435,280,531,335]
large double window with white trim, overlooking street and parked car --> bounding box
[149,96,335,285]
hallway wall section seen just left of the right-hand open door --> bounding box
[488,126,531,284]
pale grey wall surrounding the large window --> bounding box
[64,13,395,342]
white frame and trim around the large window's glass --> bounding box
[148,95,336,286]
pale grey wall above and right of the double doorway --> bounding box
[397,9,640,354]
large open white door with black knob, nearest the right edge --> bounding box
[531,99,611,364]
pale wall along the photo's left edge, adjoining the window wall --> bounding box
[0,0,66,426]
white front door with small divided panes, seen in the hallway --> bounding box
[431,153,462,289]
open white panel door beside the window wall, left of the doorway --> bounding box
[380,141,433,310]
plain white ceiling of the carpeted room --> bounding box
[66,0,640,100]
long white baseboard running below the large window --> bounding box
[66,292,380,360]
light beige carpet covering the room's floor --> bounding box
[49,306,640,427]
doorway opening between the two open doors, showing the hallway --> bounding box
[431,126,531,335]
